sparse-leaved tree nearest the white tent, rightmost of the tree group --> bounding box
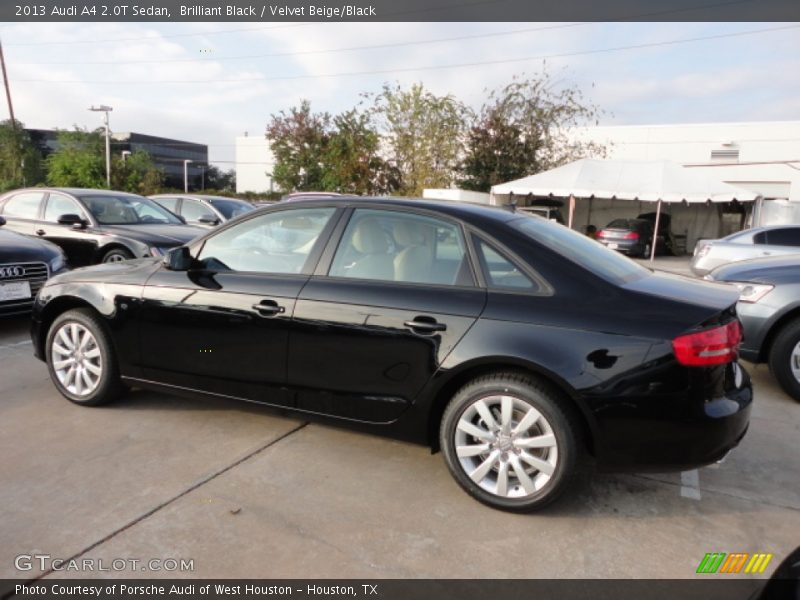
[459,71,605,192]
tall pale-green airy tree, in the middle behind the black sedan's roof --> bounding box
[373,83,470,196]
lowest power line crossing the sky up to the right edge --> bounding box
[16,24,800,85]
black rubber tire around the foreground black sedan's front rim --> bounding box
[45,308,125,406]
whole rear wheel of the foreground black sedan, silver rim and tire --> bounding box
[440,373,580,512]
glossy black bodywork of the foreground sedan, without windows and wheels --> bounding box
[32,198,752,470]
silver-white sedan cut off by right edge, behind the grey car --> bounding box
[691,225,800,277]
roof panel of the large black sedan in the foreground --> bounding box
[260,196,528,222]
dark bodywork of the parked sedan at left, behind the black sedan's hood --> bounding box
[0,188,205,267]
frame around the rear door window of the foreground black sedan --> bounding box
[313,204,484,290]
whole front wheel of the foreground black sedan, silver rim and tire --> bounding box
[46,308,124,406]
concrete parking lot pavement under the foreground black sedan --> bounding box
[0,256,800,579]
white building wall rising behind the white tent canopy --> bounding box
[572,121,800,201]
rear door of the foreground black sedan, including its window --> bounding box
[288,208,486,423]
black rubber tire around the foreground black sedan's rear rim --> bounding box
[439,373,582,512]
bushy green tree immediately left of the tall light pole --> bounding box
[47,127,107,188]
